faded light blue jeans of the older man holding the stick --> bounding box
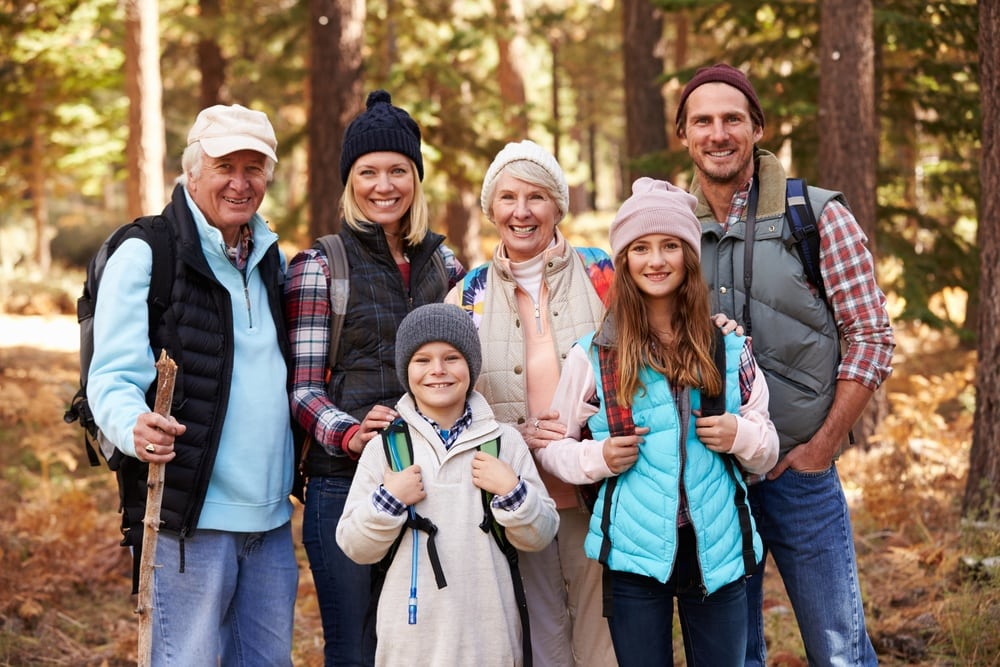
[152,523,299,667]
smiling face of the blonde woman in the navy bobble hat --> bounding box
[351,151,416,233]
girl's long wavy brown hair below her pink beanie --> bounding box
[601,241,722,406]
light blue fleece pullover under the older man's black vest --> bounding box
[87,189,294,532]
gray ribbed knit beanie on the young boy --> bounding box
[396,303,483,393]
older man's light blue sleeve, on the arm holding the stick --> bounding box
[87,238,156,456]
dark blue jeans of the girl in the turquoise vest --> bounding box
[608,526,747,667]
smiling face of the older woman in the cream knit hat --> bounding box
[491,171,562,262]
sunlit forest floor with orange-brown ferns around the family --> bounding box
[0,311,1000,666]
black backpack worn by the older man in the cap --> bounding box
[63,215,175,470]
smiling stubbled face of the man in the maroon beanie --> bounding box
[681,83,764,186]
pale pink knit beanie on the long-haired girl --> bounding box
[609,176,701,259]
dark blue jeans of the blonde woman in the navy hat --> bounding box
[302,477,375,667]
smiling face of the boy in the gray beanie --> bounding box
[406,341,469,428]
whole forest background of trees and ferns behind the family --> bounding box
[0,0,1000,665]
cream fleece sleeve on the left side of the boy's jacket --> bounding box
[336,437,406,565]
